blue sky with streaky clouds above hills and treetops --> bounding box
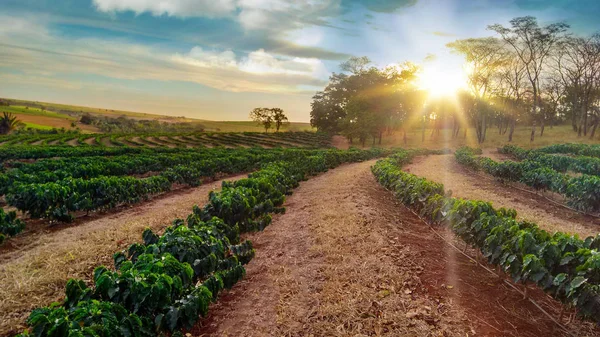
[0,0,600,122]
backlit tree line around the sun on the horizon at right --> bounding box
[311,16,600,144]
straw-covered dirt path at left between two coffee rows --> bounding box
[0,175,246,336]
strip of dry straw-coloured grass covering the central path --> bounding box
[191,161,470,336]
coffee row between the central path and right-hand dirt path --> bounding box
[373,152,600,323]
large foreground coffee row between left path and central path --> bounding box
[15,150,390,337]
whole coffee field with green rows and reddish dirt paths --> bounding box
[0,129,600,336]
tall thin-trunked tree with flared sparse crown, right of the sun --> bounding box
[488,16,569,141]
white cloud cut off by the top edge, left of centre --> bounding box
[93,0,236,18]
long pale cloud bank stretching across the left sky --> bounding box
[0,15,328,93]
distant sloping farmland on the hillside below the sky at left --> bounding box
[0,99,315,132]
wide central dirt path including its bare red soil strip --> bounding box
[190,161,596,337]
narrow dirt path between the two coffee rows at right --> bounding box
[405,155,600,238]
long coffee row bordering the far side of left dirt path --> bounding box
[0,149,376,222]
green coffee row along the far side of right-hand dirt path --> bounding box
[455,147,600,212]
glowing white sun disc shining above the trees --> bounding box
[417,67,467,98]
